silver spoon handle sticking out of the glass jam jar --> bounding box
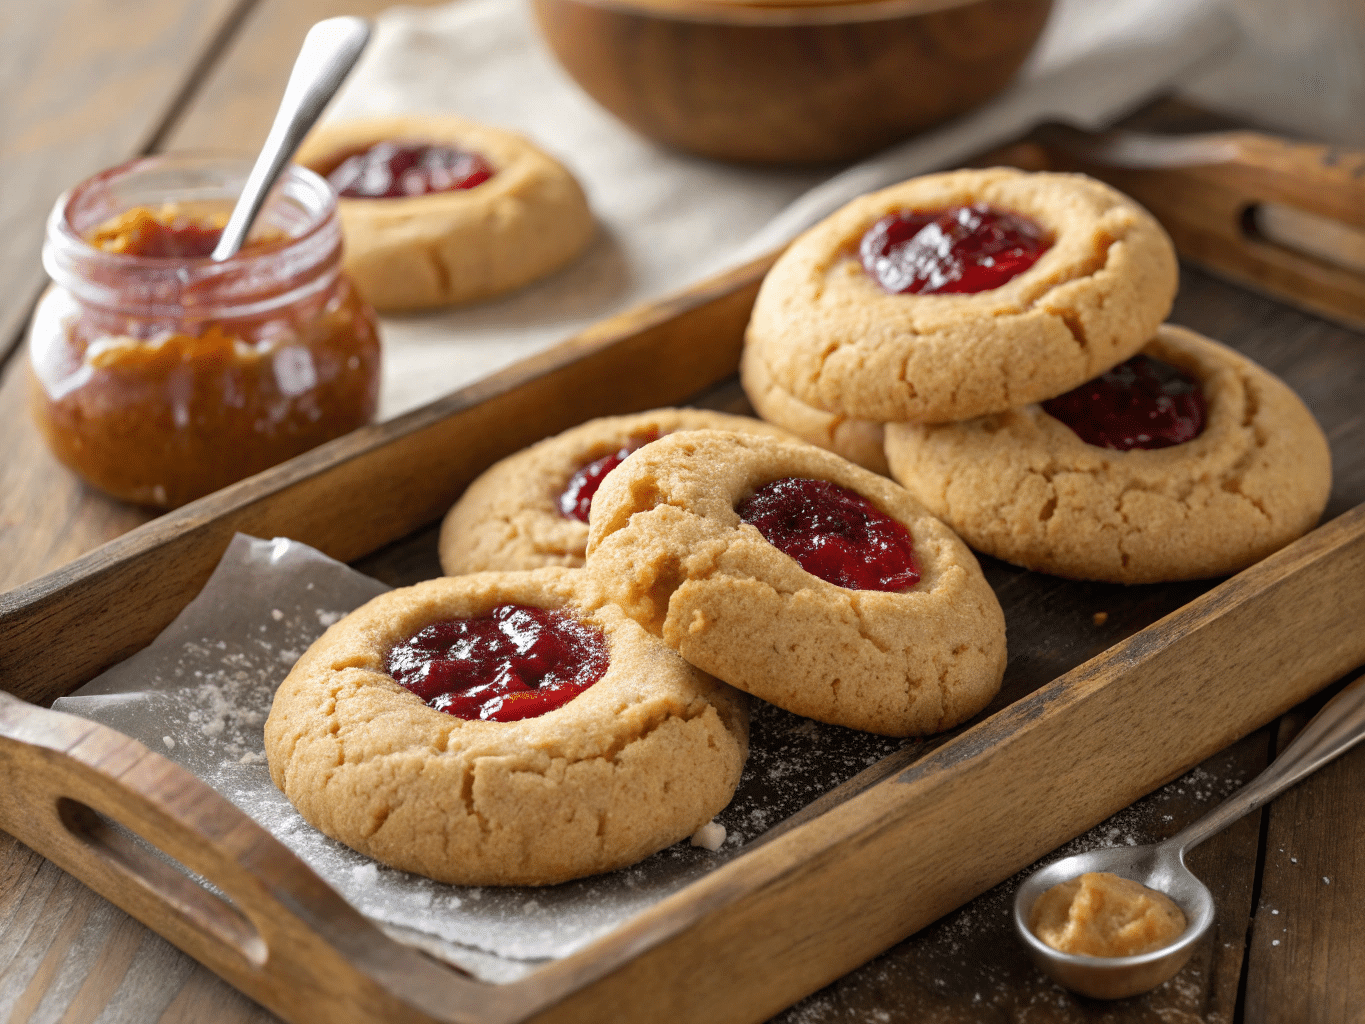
[212,18,370,261]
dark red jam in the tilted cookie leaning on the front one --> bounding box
[734,477,920,590]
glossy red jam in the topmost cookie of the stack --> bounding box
[859,203,1052,295]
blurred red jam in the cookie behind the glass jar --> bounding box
[326,142,493,199]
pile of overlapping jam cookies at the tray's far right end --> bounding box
[741,168,1331,583]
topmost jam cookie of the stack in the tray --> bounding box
[748,168,1177,423]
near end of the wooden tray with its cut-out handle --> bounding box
[0,692,516,1024]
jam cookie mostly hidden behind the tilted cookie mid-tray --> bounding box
[440,408,790,576]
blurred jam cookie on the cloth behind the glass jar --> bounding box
[296,116,595,310]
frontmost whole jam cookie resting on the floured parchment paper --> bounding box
[265,569,748,885]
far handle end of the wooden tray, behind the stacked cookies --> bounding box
[992,124,1365,328]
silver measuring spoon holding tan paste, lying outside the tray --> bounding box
[1014,677,1365,999]
